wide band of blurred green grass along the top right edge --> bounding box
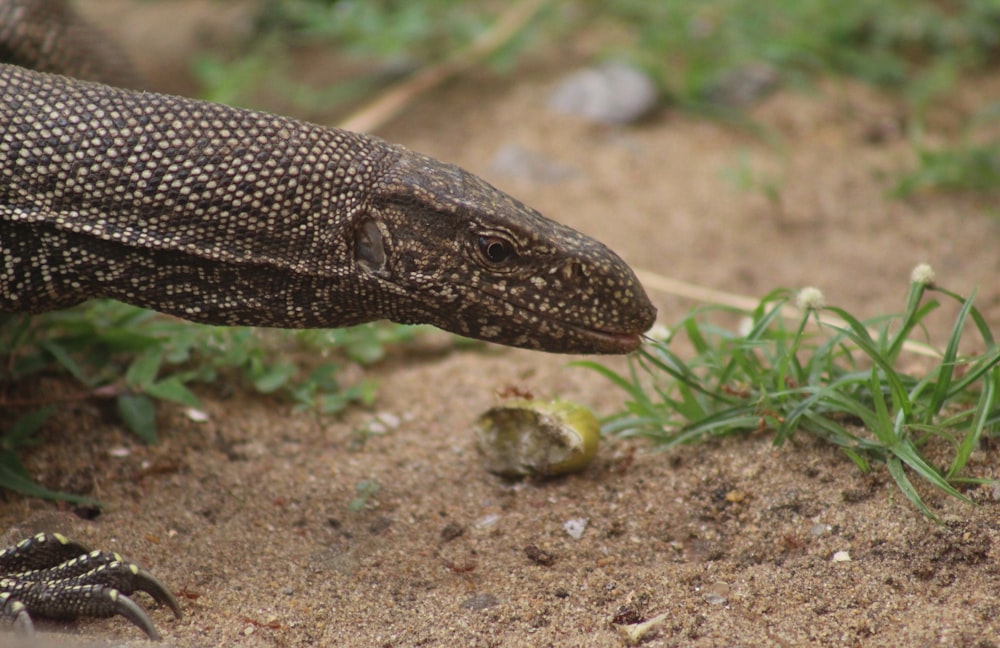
[594,0,1000,103]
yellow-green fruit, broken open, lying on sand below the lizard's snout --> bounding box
[476,400,601,477]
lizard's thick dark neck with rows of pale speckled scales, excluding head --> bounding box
[0,66,402,327]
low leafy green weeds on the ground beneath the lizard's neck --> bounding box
[0,300,420,501]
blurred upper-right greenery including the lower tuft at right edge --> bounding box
[589,0,1000,197]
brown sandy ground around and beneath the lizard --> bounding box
[0,2,1000,647]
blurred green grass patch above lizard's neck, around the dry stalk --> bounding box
[194,0,550,111]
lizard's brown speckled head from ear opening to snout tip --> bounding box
[354,150,656,353]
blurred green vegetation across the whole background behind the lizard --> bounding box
[198,0,1000,196]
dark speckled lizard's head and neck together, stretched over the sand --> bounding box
[0,65,655,353]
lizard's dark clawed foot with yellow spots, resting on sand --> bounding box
[0,533,181,640]
